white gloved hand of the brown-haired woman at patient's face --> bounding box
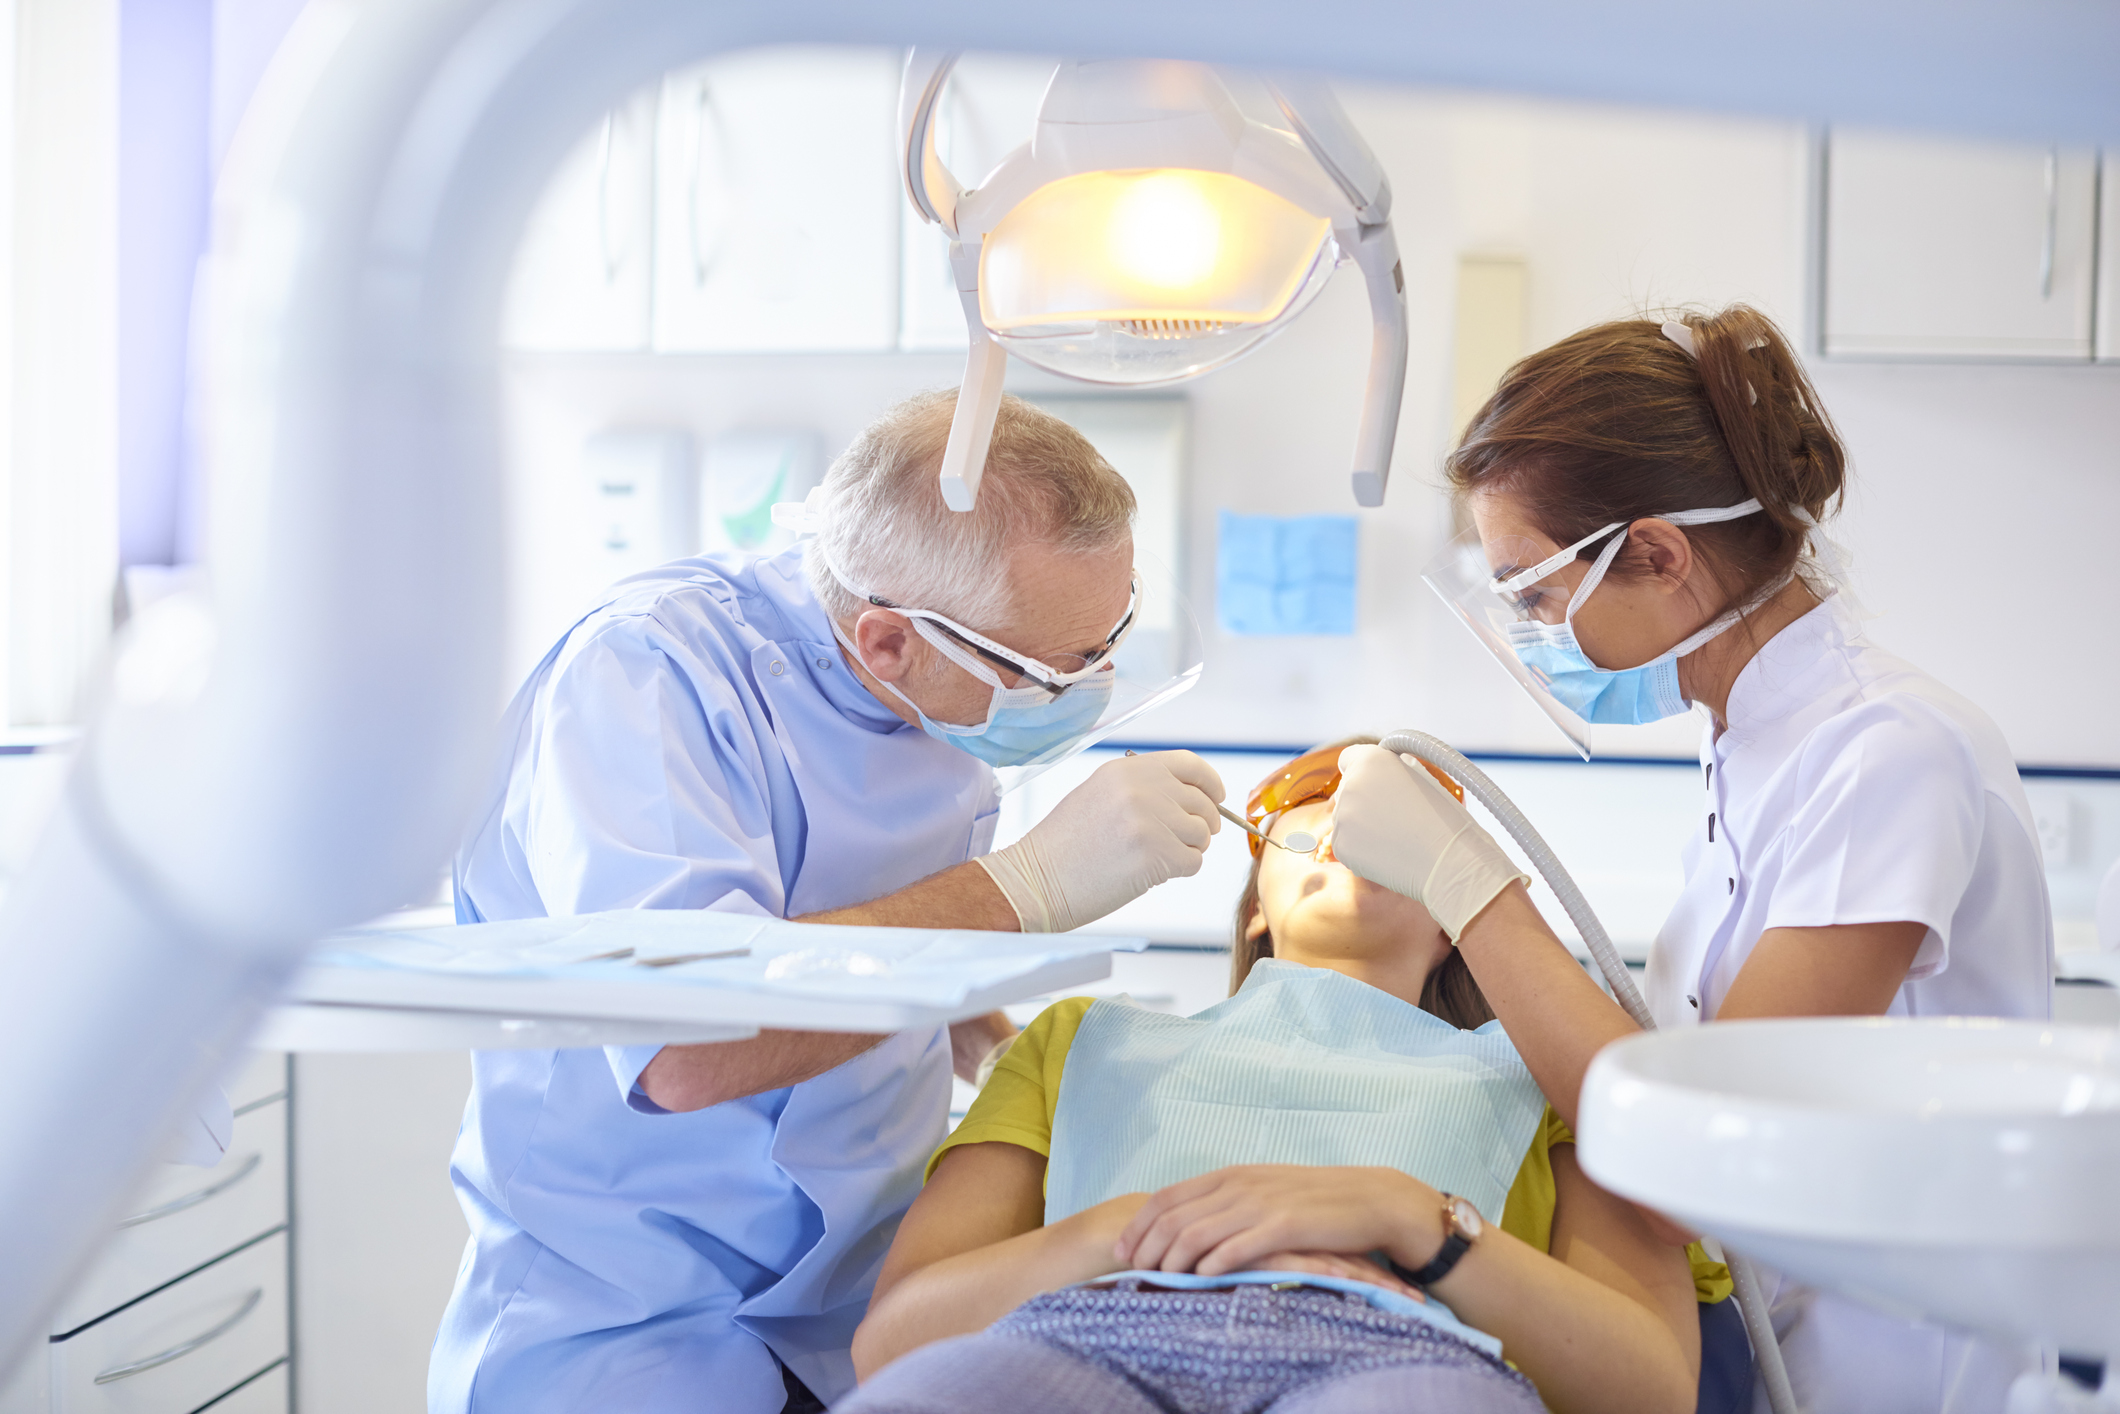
[1331,746,1531,943]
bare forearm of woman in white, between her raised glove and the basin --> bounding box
[1456,884,1641,1128]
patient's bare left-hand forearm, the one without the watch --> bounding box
[854,1194,1147,1380]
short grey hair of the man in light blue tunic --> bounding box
[803,388,1134,628]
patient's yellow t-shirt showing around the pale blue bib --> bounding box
[926,996,1730,1302]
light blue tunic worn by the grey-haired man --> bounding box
[428,547,999,1414]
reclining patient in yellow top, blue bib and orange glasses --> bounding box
[837,742,1728,1414]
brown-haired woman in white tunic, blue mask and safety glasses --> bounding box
[1333,305,2054,1414]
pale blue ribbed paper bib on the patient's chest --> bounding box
[1045,958,1545,1223]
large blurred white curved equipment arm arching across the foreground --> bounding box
[0,0,2120,1369]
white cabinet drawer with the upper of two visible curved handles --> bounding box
[51,1100,286,1336]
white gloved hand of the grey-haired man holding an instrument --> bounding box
[979,750,1223,933]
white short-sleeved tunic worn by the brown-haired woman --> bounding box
[1647,598,2054,1414]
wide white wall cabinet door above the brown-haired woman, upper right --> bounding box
[1823,129,2097,360]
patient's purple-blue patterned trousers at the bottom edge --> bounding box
[837,1280,1545,1414]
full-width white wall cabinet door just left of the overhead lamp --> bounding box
[655,49,903,354]
